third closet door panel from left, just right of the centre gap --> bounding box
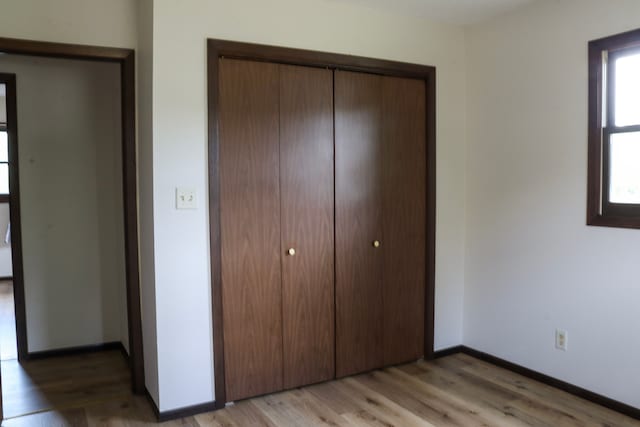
[334,71,385,377]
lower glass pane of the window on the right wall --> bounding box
[609,132,640,204]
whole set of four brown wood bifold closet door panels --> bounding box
[217,58,427,401]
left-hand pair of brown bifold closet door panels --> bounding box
[219,59,335,400]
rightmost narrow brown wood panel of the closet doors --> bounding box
[382,77,426,365]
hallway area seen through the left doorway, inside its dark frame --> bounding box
[0,50,141,422]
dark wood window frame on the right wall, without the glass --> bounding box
[587,30,640,228]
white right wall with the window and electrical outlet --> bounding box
[464,0,640,407]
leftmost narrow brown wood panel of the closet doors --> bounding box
[219,59,282,401]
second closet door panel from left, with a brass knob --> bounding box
[280,65,335,388]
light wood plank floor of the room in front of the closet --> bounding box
[2,354,640,427]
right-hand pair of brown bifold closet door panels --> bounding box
[335,71,426,377]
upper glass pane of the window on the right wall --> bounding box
[614,53,640,126]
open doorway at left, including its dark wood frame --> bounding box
[0,38,144,418]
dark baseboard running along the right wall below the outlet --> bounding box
[436,346,640,420]
